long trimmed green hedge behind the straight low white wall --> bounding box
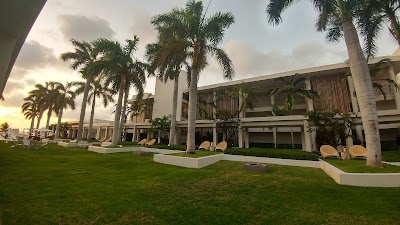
[225,148,319,161]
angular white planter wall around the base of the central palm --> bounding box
[153,154,223,168]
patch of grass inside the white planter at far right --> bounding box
[325,159,400,173]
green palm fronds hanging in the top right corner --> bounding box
[359,0,400,56]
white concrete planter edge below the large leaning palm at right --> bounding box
[320,160,400,187]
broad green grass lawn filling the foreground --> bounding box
[0,142,400,225]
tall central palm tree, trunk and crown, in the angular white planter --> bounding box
[151,0,234,154]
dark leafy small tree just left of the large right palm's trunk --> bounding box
[307,110,355,148]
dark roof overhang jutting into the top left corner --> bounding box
[0,0,46,96]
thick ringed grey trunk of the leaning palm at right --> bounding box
[342,17,382,167]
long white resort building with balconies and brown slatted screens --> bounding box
[72,56,400,151]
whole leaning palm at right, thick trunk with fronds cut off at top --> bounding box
[266,0,382,166]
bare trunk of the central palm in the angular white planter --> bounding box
[186,69,199,154]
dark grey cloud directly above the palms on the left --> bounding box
[58,15,115,41]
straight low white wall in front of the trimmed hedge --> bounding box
[223,154,320,168]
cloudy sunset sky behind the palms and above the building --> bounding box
[0,0,397,130]
